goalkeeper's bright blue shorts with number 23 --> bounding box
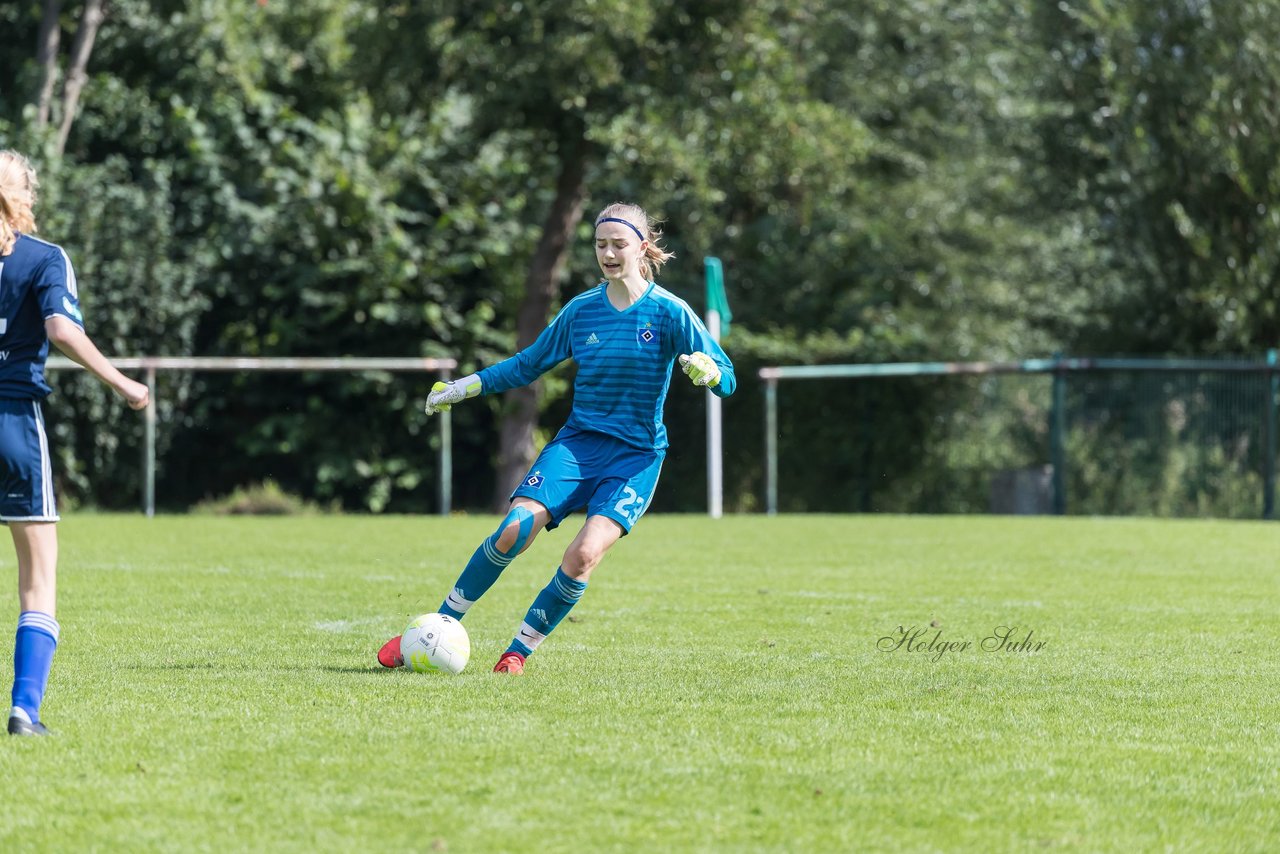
[511,430,667,536]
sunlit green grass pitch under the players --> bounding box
[0,515,1280,851]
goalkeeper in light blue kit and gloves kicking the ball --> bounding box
[378,205,736,673]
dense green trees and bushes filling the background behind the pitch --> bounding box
[0,0,1280,511]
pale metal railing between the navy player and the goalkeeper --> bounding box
[45,356,458,516]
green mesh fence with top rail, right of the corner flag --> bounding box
[759,351,1280,519]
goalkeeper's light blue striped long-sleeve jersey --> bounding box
[479,283,737,451]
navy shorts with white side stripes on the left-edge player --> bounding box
[0,399,58,522]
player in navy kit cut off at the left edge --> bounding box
[0,151,150,735]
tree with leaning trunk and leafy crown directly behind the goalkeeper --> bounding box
[373,0,890,506]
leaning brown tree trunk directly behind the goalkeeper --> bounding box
[493,133,586,513]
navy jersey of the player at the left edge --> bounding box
[0,234,83,399]
